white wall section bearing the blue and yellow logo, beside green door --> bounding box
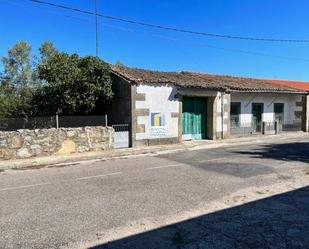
[136,84,179,140]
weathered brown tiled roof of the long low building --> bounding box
[112,66,303,92]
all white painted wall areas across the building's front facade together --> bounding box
[136,88,302,140]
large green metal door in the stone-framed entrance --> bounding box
[182,97,207,140]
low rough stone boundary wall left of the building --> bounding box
[0,127,114,160]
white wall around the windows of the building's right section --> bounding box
[231,93,302,125]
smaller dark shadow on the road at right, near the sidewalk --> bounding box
[233,142,309,163]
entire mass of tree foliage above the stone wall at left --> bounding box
[0,41,113,118]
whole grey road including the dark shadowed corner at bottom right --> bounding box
[0,136,309,249]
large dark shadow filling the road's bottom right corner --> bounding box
[92,186,309,249]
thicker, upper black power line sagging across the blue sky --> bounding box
[29,0,309,43]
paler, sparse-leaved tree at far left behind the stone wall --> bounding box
[0,41,57,118]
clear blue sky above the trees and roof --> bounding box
[0,0,309,81]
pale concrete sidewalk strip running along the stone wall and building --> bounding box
[0,132,309,170]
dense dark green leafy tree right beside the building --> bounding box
[35,52,113,115]
